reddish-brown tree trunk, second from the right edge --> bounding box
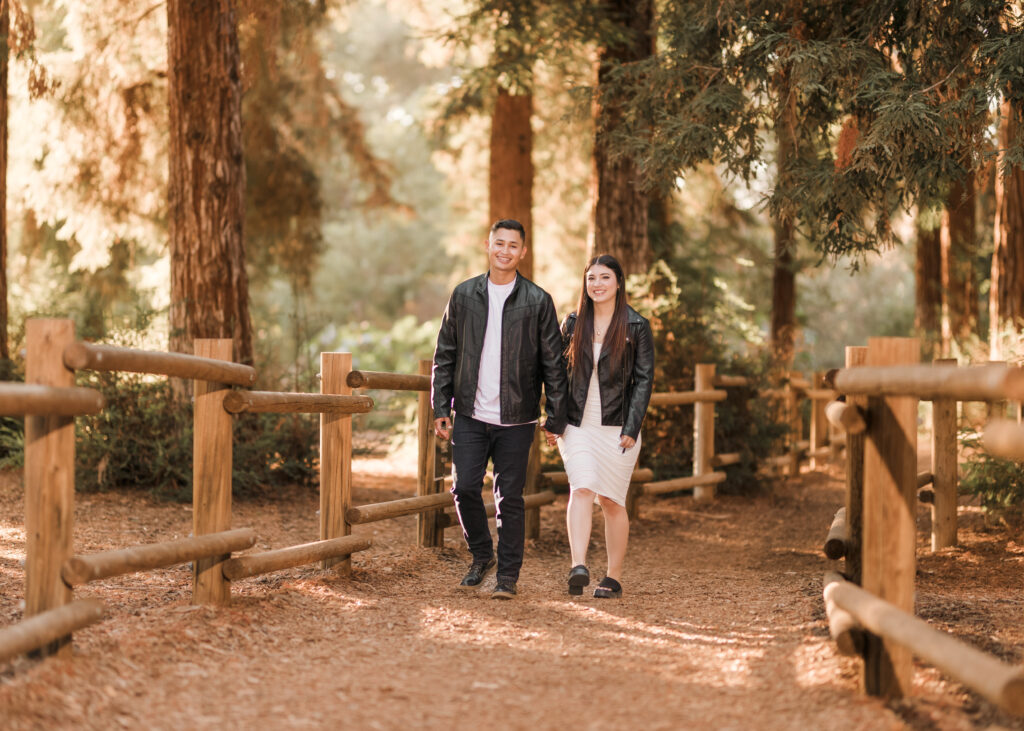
[941,173,978,355]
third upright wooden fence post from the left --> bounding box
[321,353,352,575]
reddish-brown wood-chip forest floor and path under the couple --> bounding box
[0,446,1024,731]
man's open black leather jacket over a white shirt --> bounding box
[430,272,566,434]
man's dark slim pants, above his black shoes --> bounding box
[452,414,537,582]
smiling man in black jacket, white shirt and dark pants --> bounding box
[431,220,567,599]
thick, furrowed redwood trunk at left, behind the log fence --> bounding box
[167,0,253,362]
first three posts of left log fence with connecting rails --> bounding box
[0,319,374,662]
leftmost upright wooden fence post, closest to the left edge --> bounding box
[25,319,75,657]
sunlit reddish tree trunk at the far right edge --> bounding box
[988,102,1024,360]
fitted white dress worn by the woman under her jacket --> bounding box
[558,343,640,506]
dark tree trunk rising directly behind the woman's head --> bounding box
[590,0,654,273]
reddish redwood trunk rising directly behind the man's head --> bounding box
[489,88,534,278]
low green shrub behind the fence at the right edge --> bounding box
[959,432,1024,523]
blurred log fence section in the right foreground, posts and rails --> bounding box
[823,338,1024,714]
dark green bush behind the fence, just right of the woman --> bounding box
[630,262,785,492]
